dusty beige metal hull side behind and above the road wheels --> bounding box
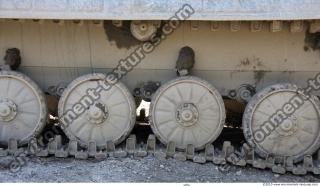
[0,20,320,95]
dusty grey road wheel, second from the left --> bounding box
[58,74,136,148]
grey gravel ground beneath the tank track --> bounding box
[0,156,320,182]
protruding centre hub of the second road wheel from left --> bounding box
[87,103,108,124]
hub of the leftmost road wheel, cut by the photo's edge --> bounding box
[0,99,17,122]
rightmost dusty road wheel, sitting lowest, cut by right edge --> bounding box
[242,84,320,161]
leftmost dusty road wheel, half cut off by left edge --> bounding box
[0,71,47,145]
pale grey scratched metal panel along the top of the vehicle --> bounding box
[0,0,320,20]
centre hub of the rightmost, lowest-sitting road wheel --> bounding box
[277,116,298,136]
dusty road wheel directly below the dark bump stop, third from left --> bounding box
[149,76,225,149]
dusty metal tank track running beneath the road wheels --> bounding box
[0,134,320,175]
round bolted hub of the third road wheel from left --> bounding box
[176,103,199,127]
